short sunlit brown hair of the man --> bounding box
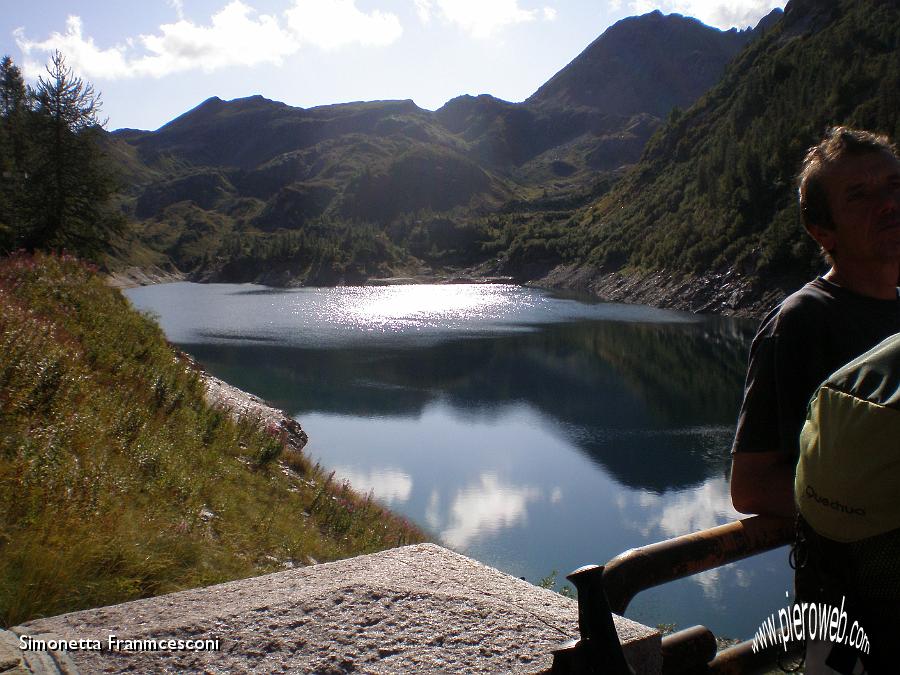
[798,127,897,230]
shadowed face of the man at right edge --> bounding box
[813,151,900,267]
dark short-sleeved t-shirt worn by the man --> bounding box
[732,277,900,458]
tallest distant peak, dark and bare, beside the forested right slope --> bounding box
[436,10,756,186]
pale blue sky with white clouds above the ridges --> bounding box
[0,0,785,130]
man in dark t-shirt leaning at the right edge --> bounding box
[731,127,900,517]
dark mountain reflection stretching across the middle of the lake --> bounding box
[182,321,746,492]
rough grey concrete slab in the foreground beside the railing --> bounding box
[13,544,661,674]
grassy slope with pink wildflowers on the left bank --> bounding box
[0,255,423,626]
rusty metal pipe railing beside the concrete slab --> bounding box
[552,516,794,675]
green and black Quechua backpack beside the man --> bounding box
[791,334,900,675]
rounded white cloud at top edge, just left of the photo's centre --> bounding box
[286,0,403,49]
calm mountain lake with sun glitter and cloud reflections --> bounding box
[126,283,793,638]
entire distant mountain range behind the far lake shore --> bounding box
[108,12,754,283]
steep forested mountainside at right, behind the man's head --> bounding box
[524,0,900,313]
